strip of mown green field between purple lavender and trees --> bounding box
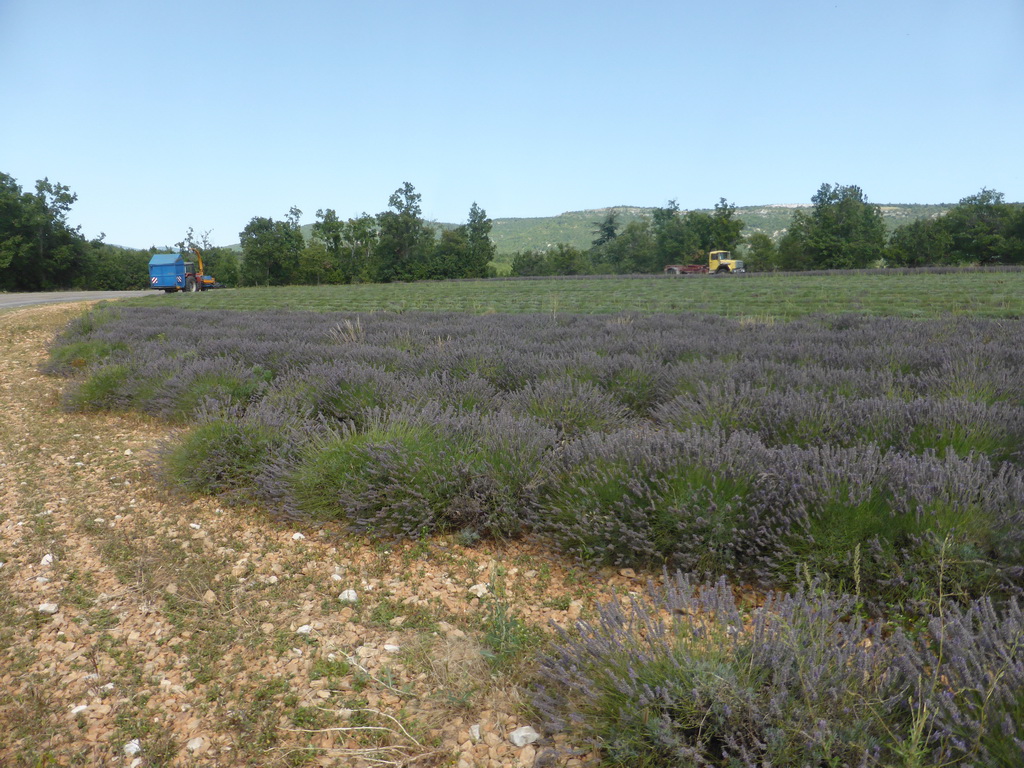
[126,270,1024,321]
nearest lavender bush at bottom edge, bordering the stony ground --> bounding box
[535,575,903,768]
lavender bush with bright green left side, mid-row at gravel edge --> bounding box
[287,410,554,538]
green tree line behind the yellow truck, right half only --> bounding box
[512,183,1024,276]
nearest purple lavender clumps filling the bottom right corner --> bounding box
[534,573,1024,768]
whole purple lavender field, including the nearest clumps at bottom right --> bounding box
[47,307,1024,765]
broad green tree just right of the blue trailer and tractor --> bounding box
[239,206,305,286]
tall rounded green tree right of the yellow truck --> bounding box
[779,183,886,269]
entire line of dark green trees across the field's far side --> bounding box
[0,173,1024,291]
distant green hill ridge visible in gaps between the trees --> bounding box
[245,204,952,262]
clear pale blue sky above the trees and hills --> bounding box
[0,0,1024,248]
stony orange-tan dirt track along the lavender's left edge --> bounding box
[0,304,618,768]
